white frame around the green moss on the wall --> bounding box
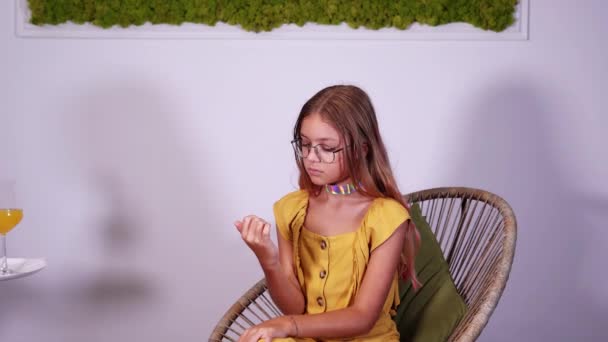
[15,0,529,41]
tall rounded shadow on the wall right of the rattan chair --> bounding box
[445,77,608,341]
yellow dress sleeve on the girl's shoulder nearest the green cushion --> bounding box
[366,198,410,251]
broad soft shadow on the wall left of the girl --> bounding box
[0,77,232,341]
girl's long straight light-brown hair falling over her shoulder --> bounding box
[293,85,421,289]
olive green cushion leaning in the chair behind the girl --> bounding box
[394,204,467,342]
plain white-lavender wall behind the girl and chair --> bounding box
[0,0,608,342]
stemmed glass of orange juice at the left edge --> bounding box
[0,181,23,275]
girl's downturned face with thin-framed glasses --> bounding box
[300,113,347,185]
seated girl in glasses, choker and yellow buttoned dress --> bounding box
[235,86,420,342]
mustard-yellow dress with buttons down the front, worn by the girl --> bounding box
[273,190,410,342]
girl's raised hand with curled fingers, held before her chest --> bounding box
[234,215,279,268]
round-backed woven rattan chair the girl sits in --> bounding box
[209,187,517,342]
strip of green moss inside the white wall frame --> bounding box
[28,0,518,32]
